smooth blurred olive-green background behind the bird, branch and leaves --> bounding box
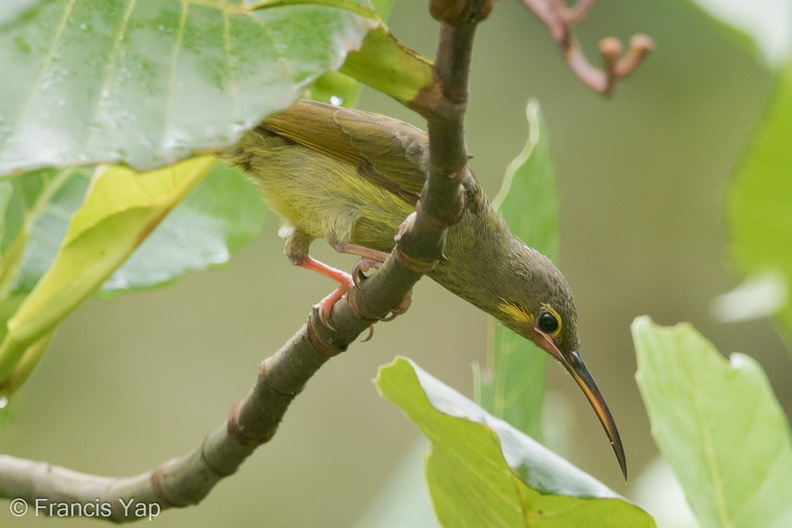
[0,0,780,527]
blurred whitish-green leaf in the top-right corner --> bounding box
[680,0,792,67]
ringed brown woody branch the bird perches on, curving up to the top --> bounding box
[0,0,494,523]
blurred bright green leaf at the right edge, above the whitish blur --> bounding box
[726,59,792,344]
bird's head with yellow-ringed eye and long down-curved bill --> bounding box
[496,248,627,478]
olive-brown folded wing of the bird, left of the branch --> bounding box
[261,101,429,204]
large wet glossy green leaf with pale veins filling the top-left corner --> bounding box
[0,0,376,174]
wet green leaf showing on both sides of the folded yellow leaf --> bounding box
[0,163,266,302]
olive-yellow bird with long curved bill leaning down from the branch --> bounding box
[223,100,627,479]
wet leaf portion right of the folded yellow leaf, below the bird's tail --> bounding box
[99,163,267,297]
